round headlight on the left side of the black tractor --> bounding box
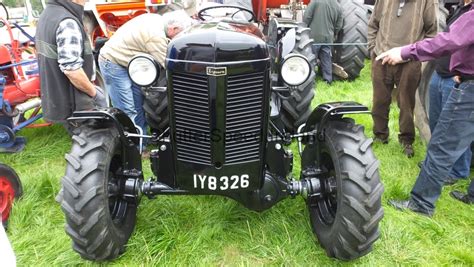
[128,55,160,87]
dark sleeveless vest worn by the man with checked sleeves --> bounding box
[36,0,94,122]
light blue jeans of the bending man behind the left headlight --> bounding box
[99,57,147,134]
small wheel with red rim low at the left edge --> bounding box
[0,163,23,228]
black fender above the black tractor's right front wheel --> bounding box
[303,101,370,140]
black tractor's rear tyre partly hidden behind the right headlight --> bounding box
[280,26,316,132]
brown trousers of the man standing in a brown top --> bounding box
[372,58,421,145]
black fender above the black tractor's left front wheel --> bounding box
[67,108,142,171]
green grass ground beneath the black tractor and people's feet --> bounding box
[0,61,474,266]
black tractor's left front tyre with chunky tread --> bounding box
[59,127,137,261]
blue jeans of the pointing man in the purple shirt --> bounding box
[411,81,474,211]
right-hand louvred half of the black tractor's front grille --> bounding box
[225,72,265,164]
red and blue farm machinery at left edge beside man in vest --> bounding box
[0,3,50,152]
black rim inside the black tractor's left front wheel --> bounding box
[107,154,128,226]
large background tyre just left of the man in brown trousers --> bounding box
[333,0,369,80]
